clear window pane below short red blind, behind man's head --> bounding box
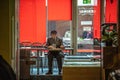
[48,20,71,47]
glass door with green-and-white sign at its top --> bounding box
[77,0,100,56]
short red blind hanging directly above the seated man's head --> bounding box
[48,0,72,20]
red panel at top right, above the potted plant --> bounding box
[105,0,118,22]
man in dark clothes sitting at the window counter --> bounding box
[46,30,64,74]
